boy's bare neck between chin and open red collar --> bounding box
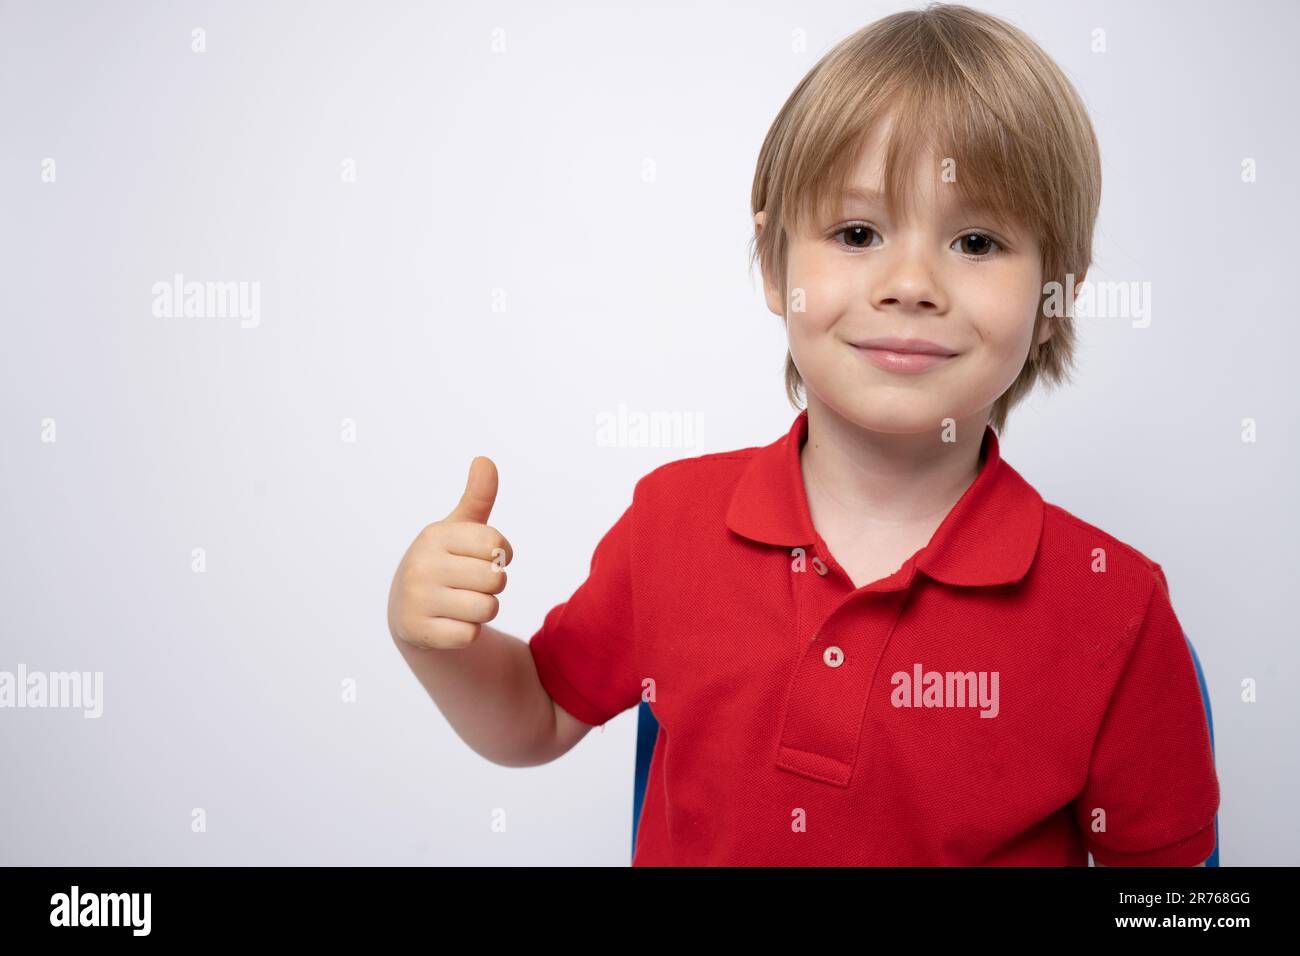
[800,394,988,536]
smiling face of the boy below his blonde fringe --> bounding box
[757,113,1052,433]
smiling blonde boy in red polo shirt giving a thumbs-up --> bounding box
[389,7,1219,865]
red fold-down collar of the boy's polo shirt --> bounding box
[727,408,1043,587]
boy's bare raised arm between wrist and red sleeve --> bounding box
[394,624,592,767]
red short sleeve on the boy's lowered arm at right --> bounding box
[1074,564,1219,866]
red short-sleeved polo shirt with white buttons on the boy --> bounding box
[529,411,1219,866]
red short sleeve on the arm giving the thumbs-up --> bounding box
[528,494,641,726]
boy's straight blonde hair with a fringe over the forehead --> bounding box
[750,4,1101,432]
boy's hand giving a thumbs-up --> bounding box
[389,455,514,649]
